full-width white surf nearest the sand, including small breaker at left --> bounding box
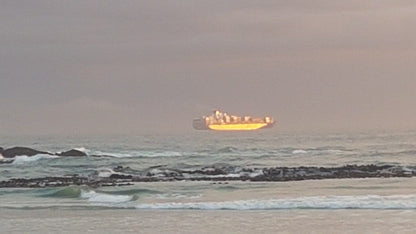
[4,194,416,211]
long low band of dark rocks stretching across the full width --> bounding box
[0,165,416,188]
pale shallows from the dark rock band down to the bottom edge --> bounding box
[0,178,416,233]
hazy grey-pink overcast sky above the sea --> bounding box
[0,0,416,135]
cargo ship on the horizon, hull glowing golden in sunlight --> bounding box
[192,110,274,131]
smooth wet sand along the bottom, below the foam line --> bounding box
[0,209,416,233]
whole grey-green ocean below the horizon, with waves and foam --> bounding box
[0,130,416,233]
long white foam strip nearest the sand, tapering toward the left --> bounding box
[135,195,416,210]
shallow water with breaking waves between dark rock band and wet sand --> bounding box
[0,178,416,210]
